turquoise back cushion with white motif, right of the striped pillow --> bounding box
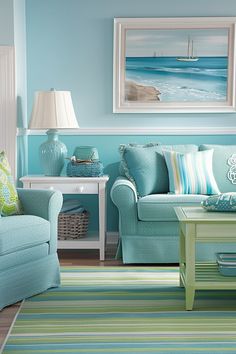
[199,144,236,193]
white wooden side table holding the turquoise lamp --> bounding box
[20,175,109,261]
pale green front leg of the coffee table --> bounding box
[185,224,195,310]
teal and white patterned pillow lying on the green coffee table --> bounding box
[201,192,236,211]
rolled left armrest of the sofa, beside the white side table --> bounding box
[111,177,138,236]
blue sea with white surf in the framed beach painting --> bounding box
[125,56,228,102]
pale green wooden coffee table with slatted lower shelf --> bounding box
[175,207,236,310]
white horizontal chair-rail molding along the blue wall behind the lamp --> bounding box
[18,126,236,136]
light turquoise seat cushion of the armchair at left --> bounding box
[0,215,50,256]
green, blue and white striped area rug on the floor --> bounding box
[3,267,236,354]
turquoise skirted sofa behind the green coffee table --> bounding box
[111,144,236,263]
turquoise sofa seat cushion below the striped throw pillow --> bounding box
[138,194,207,221]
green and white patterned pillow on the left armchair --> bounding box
[0,151,22,216]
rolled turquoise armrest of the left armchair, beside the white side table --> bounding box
[17,188,63,254]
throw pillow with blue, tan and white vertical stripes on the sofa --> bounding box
[163,149,220,195]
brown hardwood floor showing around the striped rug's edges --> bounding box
[0,250,122,353]
